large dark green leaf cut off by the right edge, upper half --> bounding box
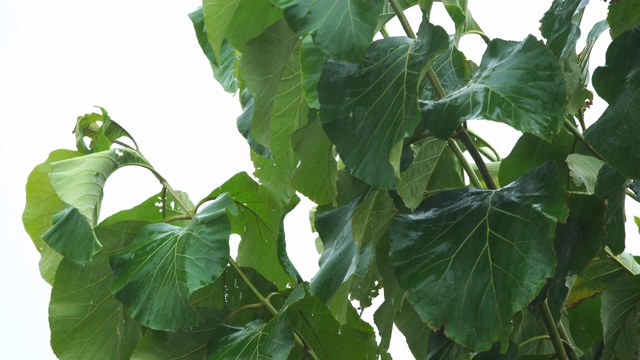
[585,28,640,178]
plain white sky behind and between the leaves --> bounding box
[0,0,624,360]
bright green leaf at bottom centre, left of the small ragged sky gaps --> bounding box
[281,285,377,360]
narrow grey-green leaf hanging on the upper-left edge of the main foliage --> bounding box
[189,7,238,93]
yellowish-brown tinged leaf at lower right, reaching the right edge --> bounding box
[566,253,640,307]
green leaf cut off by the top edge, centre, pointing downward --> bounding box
[274,0,384,63]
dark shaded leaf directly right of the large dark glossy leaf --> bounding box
[554,193,606,280]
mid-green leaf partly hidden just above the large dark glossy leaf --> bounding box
[498,130,576,184]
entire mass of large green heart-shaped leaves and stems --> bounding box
[23,0,640,359]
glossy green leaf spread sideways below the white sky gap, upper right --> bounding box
[421,36,566,141]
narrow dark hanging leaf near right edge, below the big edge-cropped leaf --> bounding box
[595,164,627,254]
